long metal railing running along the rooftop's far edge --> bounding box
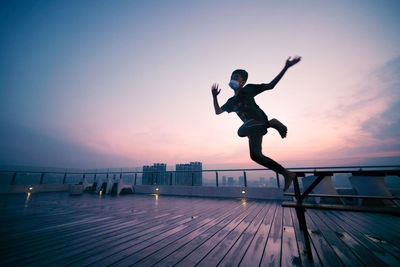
[0,165,400,188]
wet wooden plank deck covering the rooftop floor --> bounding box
[0,193,400,266]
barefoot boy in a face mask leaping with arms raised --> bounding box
[211,57,301,191]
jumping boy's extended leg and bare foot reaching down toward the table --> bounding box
[249,135,296,191]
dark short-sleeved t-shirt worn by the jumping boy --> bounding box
[221,84,268,122]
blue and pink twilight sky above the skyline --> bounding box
[0,0,400,168]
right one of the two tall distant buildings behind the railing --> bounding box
[175,162,203,185]
